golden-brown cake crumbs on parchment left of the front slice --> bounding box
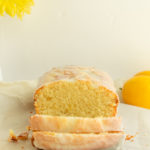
[8,130,29,142]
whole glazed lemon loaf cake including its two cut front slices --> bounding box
[30,66,125,150]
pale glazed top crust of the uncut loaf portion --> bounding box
[38,66,117,95]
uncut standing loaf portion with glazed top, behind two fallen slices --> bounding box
[34,66,118,118]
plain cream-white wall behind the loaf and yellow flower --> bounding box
[0,0,150,81]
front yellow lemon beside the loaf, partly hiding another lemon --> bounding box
[122,75,150,109]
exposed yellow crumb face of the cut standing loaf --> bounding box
[34,80,117,117]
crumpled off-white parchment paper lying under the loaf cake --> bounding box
[0,81,150,150]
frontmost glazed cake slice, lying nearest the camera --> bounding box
[33,132,124,150]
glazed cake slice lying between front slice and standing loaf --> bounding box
[30,115,122,133]
